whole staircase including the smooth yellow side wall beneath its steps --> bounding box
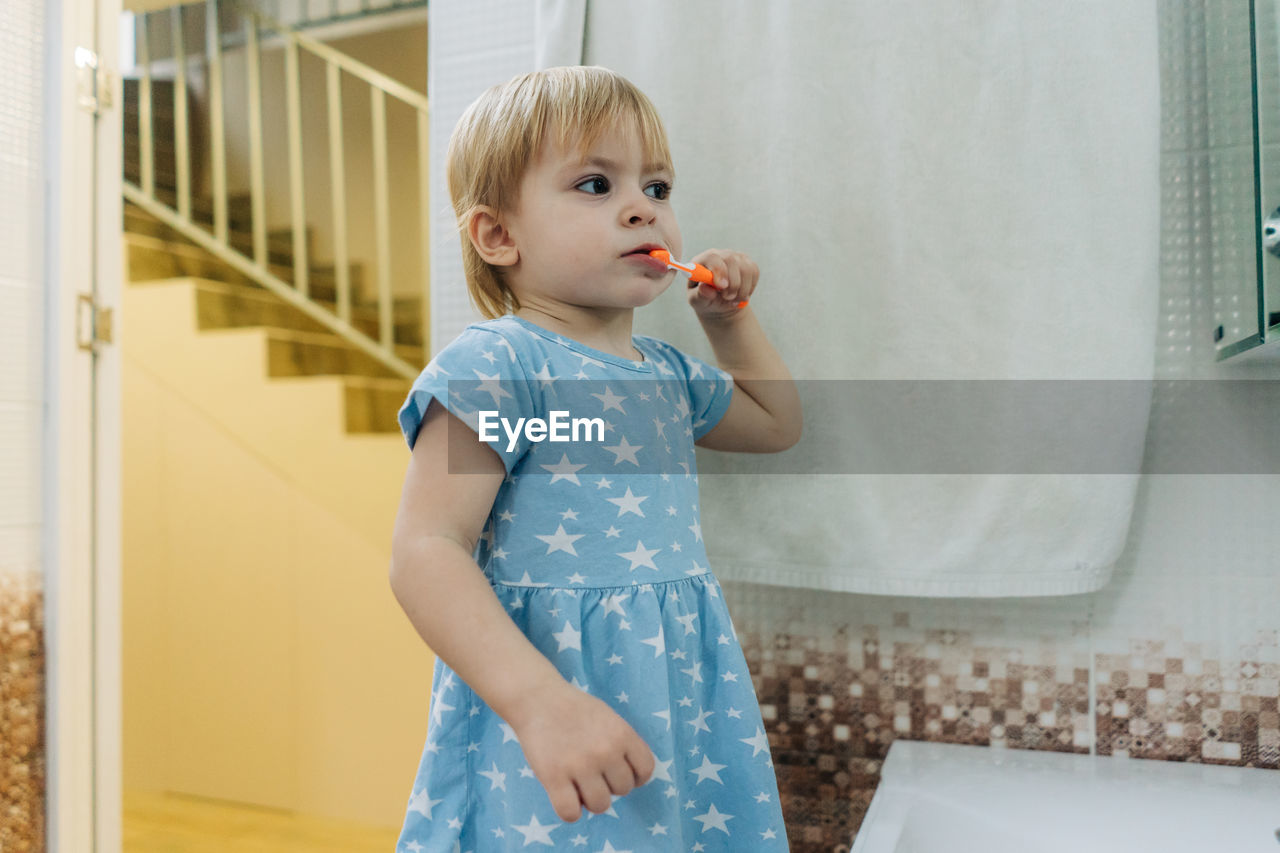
[118,13,434,824]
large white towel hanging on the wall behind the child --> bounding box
[558,0,1160,596]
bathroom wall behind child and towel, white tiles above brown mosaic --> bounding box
[430,0,1280,853]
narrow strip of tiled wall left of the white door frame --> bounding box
[0,0,46,850]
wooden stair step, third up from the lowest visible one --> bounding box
[186,279,422,345]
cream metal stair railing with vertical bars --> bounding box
[124,0,430,379]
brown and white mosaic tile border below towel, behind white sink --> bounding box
[739,613,1280,853]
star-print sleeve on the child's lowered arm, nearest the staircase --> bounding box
[398,327,540,474]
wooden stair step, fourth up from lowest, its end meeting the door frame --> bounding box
[124,227,370,305]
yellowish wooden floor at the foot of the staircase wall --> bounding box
[124,792,399,853]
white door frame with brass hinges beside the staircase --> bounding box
[44,0,123,853]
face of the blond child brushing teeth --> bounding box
[504,115,682,309]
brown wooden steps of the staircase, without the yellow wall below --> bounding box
[124,73,426,433]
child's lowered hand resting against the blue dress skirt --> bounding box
[508,681,654,822]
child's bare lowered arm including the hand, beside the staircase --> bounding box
[390,400,654,821]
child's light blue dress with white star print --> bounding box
[396,314,788,853]
